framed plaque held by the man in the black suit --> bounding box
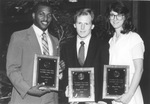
[68,68,95,102]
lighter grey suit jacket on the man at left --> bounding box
[6,27,58,104]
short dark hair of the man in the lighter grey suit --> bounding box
[32,1,52,13]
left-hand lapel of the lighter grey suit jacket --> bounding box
[27,27,42,54]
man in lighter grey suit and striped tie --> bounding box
[7,2,62,104]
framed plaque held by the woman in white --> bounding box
[103,65,129,99]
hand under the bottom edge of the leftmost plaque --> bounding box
[27,83,50,97]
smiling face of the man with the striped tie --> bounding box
[32,6,52,31]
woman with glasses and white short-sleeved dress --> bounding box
[106,2,145,104]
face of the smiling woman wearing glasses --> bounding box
[109,11,125,29]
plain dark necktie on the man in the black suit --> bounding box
[78,41,85,66]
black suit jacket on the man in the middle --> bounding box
[60,34,109,101]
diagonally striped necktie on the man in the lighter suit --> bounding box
[42,33,49,55]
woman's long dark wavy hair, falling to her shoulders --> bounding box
[106,2,135,35]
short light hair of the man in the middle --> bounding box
[74,8,94,22]
